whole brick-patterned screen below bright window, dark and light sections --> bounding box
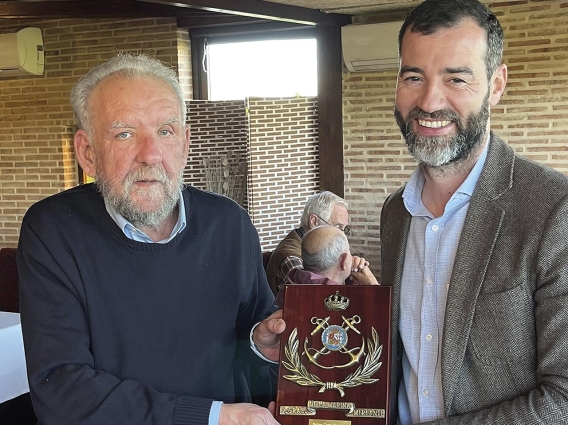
[184,98,319,250]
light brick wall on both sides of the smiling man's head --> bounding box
[343,0,568,271]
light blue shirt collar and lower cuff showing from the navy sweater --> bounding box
[105,191,223,425]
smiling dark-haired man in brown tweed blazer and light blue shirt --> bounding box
[381,0,568,425]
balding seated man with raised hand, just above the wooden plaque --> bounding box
[275,226,379,308]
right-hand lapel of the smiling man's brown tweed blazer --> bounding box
[442,134,514,414]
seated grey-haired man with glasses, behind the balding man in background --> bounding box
[266,191,350,295]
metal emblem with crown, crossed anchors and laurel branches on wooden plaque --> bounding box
[282,291,383,397]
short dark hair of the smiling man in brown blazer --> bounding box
[398,0,503,80]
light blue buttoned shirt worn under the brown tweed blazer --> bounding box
[398,142,489,425]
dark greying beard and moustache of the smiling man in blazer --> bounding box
[394,92,489,167]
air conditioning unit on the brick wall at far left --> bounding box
[0,27,44,77]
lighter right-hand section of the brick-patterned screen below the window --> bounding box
[248,98,319,250]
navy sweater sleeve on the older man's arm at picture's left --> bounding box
[18,219,213,425]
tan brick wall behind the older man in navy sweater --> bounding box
[0,18,191,246]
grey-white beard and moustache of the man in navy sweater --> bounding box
[95,166,183,229]
